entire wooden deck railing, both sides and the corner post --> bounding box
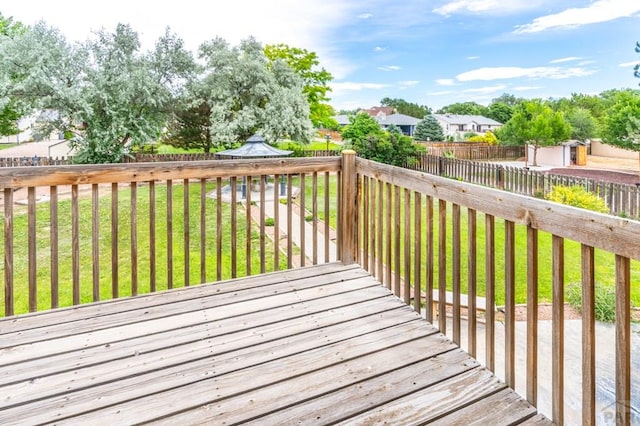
[0,151,640,424]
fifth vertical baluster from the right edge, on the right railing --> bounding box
[504,220,516,389]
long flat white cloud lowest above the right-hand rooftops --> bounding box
[456,67,595,81]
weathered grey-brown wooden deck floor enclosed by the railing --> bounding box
[0,263,550,425]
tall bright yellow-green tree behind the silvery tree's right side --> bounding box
[264,44,337,128]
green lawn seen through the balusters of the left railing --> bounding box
[0,182,286,315]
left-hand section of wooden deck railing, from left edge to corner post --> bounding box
[0,157,341,316]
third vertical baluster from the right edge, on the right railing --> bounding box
[551,235,564,425]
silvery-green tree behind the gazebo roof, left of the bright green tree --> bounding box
[196,38,312,145]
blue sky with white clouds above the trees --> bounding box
[0,0,640,111]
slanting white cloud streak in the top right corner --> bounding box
[514,0,640,34]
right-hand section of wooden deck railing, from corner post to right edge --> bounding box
[352,158,640,424]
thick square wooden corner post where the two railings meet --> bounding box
[338,149,358,265]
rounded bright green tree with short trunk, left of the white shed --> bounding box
[499,99,571,166]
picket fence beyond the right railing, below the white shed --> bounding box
[408,155,640,218]
